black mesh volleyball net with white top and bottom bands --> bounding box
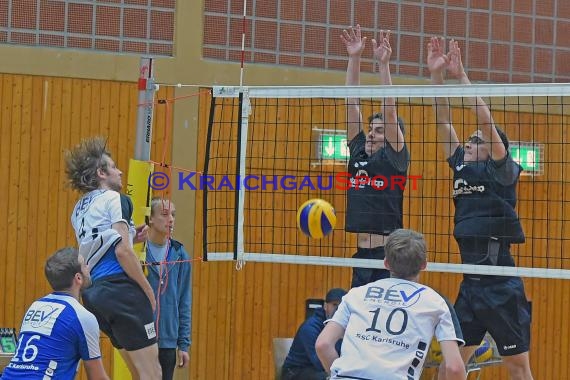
[202,84,570,278]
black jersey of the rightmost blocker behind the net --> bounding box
[447,146,525,243]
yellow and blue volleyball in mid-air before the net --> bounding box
[297,199,336,239]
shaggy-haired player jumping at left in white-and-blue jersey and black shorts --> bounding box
[66,138,161,380]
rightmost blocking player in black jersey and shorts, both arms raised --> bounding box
[428,38,532,380]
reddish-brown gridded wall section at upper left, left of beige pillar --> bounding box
[0,0,176,56]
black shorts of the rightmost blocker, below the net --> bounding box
[455,277,532,356]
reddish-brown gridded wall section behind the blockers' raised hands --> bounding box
[203,0,570,83]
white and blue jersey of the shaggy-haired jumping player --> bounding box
[71,189,136,280]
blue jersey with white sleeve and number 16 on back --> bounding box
[2,292,101,380]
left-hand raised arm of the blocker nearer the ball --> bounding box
[340,25,366,141]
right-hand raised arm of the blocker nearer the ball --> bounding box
[372,30,404,152]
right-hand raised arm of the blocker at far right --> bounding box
[448,40,507,161]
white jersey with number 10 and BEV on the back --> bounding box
[327,278,465,380]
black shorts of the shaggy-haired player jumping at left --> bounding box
[82,274,156,351]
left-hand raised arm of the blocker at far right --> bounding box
[427,37,459,158]
